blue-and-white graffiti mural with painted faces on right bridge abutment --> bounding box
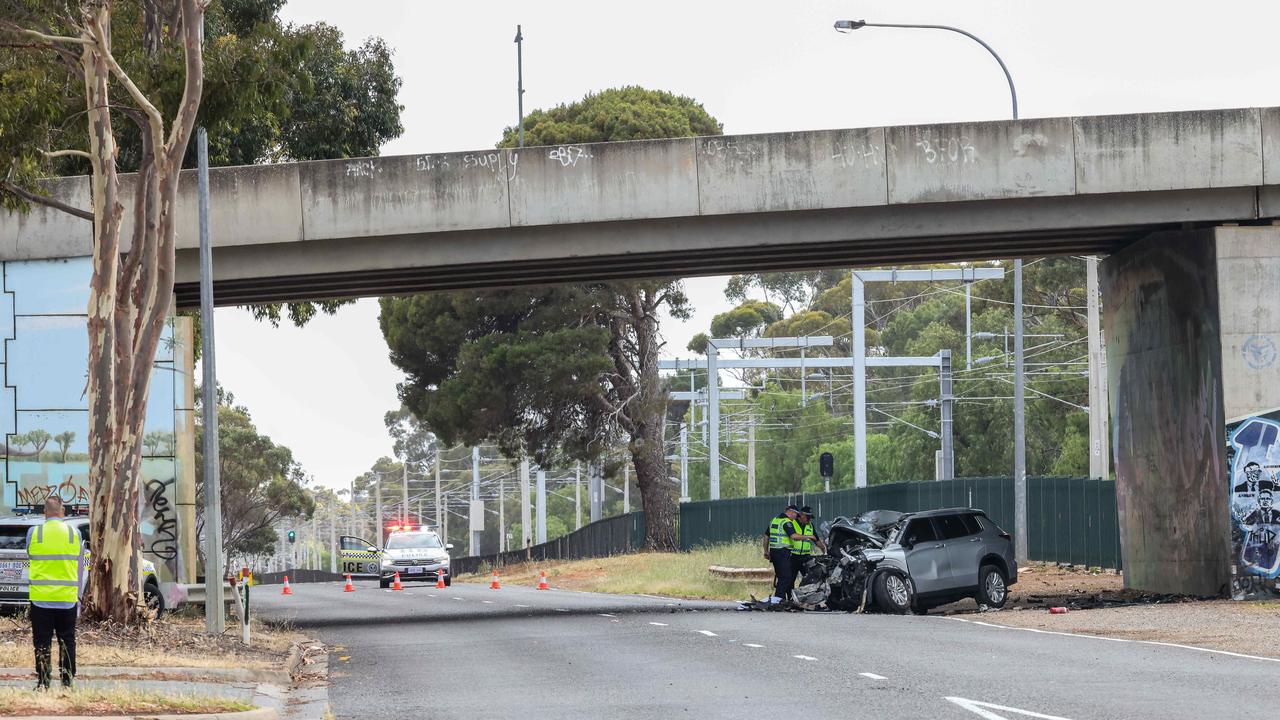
[1228,410,1280,600]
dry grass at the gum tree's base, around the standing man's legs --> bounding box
[0,607,303,670]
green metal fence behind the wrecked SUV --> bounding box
[680,477,1120,569]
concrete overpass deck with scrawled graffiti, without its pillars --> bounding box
[0,108,1280,306]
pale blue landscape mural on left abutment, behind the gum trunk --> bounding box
[0,258,195,580]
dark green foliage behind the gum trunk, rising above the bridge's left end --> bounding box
[0,0,403,325]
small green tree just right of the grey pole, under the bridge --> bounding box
[196,393,315,569]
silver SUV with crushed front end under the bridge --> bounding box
[795,507,1018,614]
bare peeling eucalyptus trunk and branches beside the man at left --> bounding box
[0,0,205,623]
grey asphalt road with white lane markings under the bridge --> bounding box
[253,580,1280,720]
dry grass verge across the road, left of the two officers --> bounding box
[458,541,769,600]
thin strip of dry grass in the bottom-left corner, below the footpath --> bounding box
[0,688,253,717]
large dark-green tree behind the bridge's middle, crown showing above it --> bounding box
[380,87,722,548]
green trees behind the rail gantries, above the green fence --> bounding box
[686,258,1088,498]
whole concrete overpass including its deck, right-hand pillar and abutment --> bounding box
[0,108,1280,594]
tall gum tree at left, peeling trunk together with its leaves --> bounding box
[0,0,207,623]
